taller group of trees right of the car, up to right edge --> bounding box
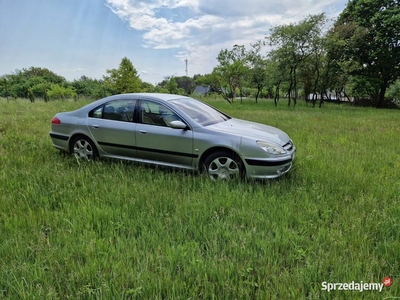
[202,0,400,107]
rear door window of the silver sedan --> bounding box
[89,100,136,122]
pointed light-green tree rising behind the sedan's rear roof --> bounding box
[104,57,141,94]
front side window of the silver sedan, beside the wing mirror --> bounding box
[140,100,181,127]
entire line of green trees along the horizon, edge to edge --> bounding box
[0,0,400,107]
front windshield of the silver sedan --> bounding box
[171,98,230,126]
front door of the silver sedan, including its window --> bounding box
[136,100,195,167]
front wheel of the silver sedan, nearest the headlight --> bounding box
[204,151,245,181]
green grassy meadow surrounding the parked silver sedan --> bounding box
[0,99,400,299]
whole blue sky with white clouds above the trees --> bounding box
[0,0,347,84]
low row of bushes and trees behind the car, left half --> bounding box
[0,57,196,102]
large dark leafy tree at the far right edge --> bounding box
[332,0,400,107]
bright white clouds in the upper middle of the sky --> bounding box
[106,0,346,78]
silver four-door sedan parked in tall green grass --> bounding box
[50,93,296,181]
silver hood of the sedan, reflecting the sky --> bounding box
[207,119,290,145]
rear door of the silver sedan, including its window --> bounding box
[88,99,137,157]
